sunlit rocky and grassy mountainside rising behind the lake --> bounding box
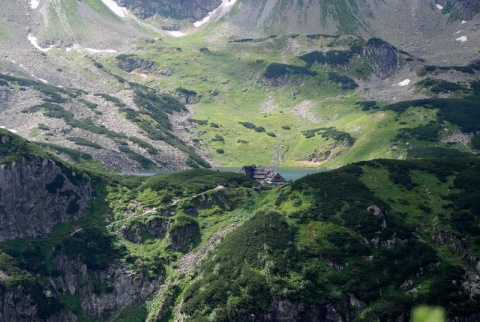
[0,0,480,171]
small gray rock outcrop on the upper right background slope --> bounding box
[364,39,400,79]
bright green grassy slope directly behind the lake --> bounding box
[100,27,476,167]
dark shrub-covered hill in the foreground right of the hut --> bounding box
[176,159,479,321]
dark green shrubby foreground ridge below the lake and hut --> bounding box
[0,130,480,321]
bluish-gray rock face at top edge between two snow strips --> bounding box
[117,0,222,21]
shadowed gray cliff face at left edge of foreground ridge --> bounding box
[0,157,92,240]
